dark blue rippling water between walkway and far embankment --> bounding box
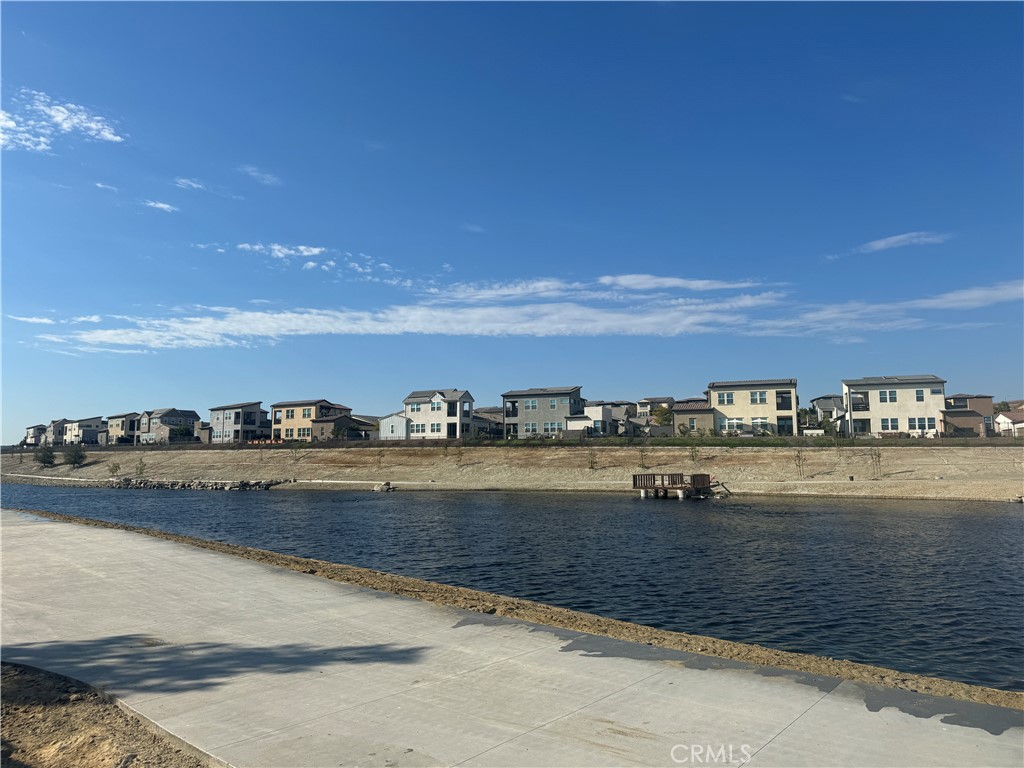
[3,484,1024,690]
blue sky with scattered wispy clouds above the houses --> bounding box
[0,2,1024,442]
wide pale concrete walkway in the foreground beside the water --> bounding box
[0,511,1024,767]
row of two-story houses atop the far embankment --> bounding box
[25,375,1024,445]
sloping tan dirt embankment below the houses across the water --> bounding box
[2,444,1024,501]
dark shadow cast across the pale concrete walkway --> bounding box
[3,635,427,694]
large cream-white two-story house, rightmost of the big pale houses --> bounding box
[843,374,946,436]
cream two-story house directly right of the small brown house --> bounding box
[705,379,800,435]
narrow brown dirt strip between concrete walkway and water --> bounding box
[9,508,1024,711]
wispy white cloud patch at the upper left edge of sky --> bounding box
[0,88,125,152]
